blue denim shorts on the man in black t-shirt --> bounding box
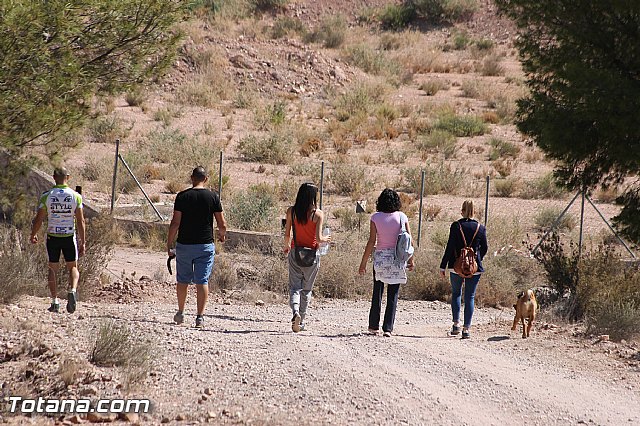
[176,243,216,285]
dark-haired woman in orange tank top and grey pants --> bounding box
[284,183,331,333]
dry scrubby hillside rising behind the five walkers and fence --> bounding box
[56,1,632,305]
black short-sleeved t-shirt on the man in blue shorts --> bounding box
[173,188,222,244]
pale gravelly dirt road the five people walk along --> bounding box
[1,289,640,425]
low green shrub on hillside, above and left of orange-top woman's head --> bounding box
[238,132,293,164]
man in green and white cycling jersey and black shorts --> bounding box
[31,167,85,313]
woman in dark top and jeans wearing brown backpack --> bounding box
[440,200,489,339]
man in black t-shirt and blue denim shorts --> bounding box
[167,167,227,328]
